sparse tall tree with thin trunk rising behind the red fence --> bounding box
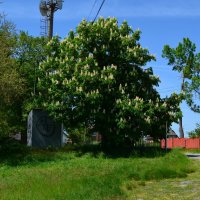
[162,38,200,137]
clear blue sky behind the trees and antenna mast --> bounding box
[0,0,200,136]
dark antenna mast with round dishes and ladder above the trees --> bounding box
[39,0,63,40]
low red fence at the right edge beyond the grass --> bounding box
[161,138,200,149]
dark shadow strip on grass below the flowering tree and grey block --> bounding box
[0,138,169,167]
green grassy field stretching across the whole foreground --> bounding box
[0,141,197,200]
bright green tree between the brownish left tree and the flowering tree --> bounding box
[14,32,48,119]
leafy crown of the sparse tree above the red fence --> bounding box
[163,38,200,112]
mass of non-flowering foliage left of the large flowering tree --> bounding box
[0,15,47,137]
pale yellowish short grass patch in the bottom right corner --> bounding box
[121,160,200,200]
